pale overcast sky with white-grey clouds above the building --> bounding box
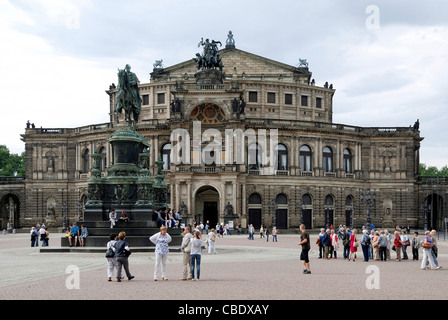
[0,0,448,168]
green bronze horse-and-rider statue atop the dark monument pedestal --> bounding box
[115,64,142,126]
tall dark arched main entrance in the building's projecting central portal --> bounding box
[194,185,220,227]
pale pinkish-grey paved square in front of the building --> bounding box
[0,233,448,300]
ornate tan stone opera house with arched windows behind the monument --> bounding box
[0,38,446,228]
